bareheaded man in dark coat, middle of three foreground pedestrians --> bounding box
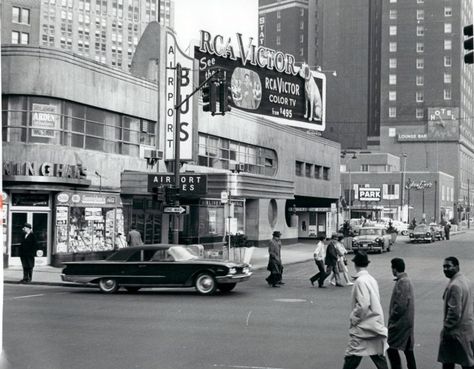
[387,258,416,369]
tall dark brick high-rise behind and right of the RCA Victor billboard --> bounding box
[260,0,474,218]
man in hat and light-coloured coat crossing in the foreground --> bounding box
[343,251,388,369]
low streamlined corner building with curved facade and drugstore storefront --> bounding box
[2,45,340,265]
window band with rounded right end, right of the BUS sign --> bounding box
[198,133,278,176]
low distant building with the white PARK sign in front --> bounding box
[341,153,455,223]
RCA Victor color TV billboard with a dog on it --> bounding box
[194,31,326,131]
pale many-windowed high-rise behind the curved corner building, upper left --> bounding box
[1,0,174,71]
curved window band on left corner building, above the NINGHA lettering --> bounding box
[2,95,156,156]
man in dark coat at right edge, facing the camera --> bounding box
[438,256,474,369]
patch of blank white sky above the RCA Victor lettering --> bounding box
[175,0,258,50]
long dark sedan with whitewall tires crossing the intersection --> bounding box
[61,244,252,295]
